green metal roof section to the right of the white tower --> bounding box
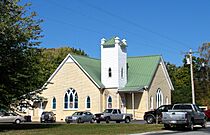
[119,55,161,91]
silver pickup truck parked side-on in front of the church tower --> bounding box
[94,109,133,123]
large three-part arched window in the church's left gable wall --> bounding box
[64,88,78,109]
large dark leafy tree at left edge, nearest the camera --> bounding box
[0,0,42,109]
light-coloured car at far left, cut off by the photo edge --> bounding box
[0,112,25,124]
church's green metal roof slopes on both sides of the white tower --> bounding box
[72,55,161,92]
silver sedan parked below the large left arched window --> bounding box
[65,112,94,123]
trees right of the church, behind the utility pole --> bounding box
[169,57,210,106]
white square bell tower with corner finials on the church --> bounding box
[101,37,127,88]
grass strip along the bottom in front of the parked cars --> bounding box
[0,124,163,135]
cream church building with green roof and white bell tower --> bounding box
[31,37,174,121]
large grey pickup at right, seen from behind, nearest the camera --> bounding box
[162,104,206,130]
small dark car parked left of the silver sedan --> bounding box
[40,112,56,123]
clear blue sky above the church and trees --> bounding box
[22,0,210,65]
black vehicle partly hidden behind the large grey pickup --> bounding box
[144,105,173,124]
